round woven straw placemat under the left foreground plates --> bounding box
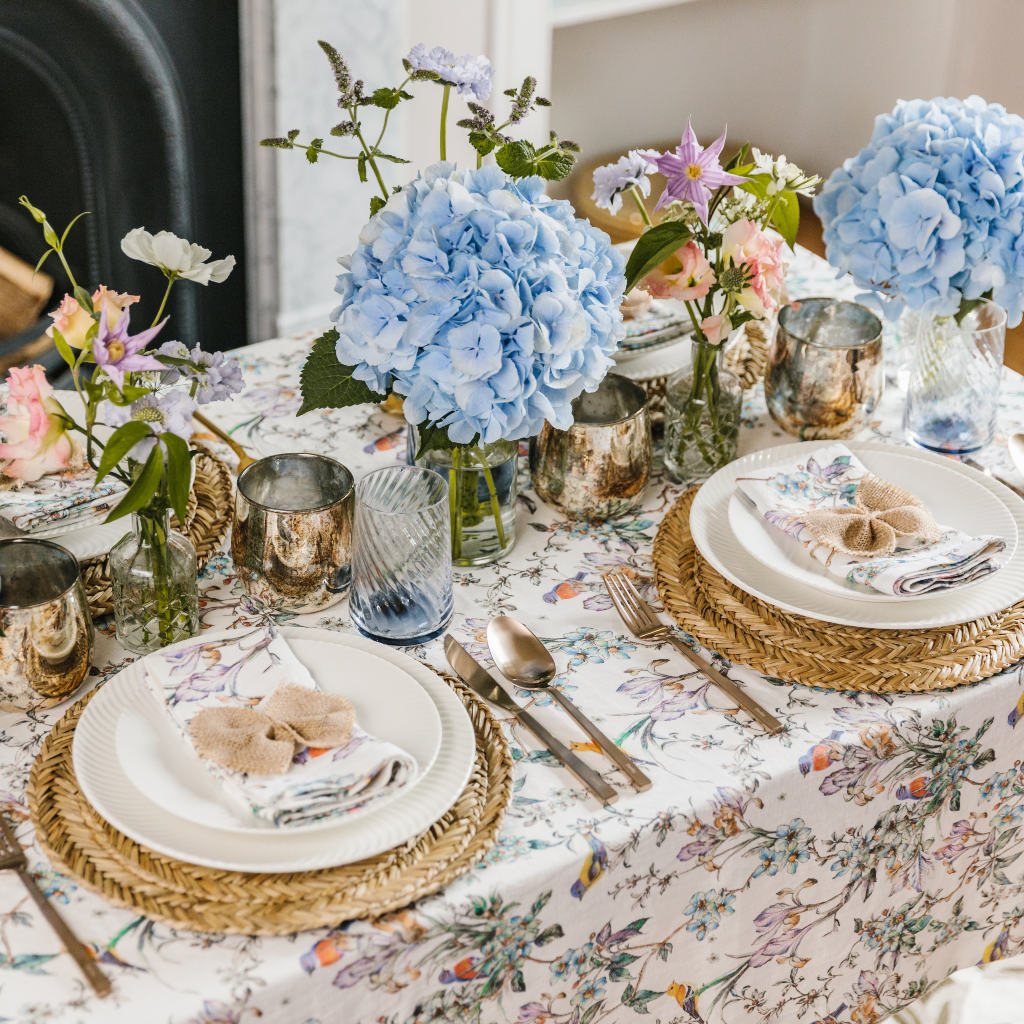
[28,677,512,935]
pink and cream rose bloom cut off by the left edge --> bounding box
[0,366,74,482]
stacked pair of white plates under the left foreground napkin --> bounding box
[72,627,476,871]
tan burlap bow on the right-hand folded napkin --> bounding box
[801,473,939,558]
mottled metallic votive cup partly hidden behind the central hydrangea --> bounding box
[529,374,653,522]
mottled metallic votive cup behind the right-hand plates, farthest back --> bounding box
[765,298,886,440]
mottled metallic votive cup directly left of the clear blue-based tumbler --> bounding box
[231,453,355,613]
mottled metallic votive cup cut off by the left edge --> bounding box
[0,538,92,711]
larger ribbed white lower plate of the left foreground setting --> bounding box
[72,627,476,871]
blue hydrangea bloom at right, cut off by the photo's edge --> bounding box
[814,96,1024,327]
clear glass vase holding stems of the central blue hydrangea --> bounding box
[409,424,519,565]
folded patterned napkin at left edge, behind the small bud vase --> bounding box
[0,466,126,534]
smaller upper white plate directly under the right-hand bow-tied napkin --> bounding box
[729,451,1018,604]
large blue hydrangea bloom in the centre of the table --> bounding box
[331,162,626,443]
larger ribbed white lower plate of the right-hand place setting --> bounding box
[690,441,1024,630]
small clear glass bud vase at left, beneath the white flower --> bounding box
[110,509,199,654]
